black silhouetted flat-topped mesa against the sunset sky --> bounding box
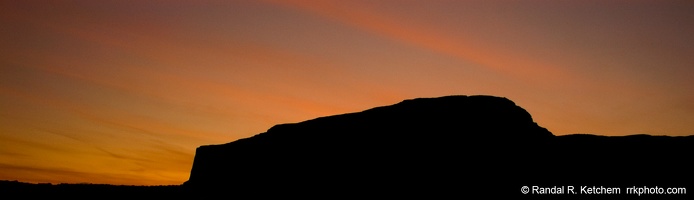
[184,96,694,195]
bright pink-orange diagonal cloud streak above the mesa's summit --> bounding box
[268,0,574,83]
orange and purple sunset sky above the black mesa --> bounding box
[0,0,694,185]
